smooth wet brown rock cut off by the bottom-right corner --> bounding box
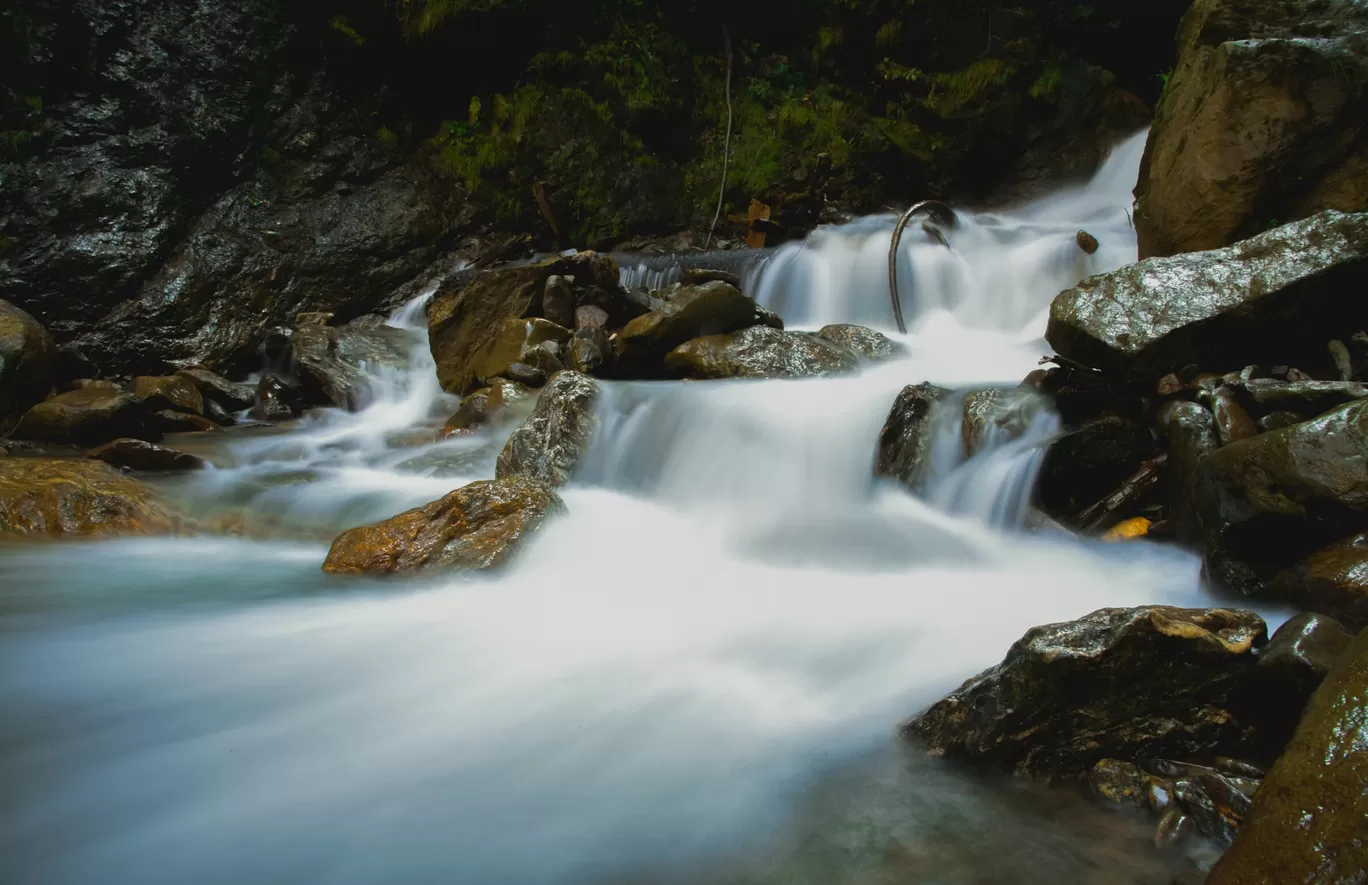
[1207,631,1368,885]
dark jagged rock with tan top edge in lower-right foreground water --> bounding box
[903,606,1267,777]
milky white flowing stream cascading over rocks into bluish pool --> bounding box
[0,135,1269,885]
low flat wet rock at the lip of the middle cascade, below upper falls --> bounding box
[665,326,859,379]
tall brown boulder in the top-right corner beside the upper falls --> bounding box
[1135,0,1368,259]
